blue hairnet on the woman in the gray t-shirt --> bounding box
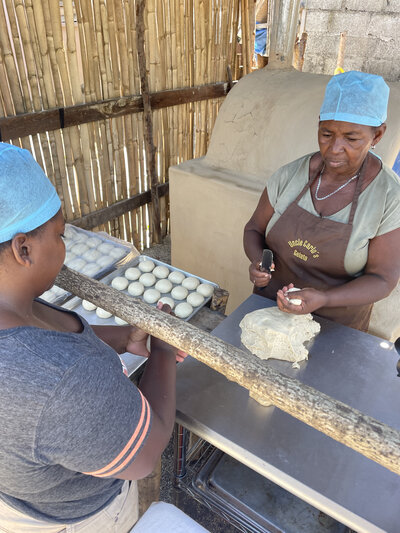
[0,142,61,243]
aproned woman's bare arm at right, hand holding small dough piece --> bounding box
[277,229,400,314]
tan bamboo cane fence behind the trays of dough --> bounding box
[0,0,250,249]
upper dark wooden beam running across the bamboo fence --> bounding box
[0,83,229,141]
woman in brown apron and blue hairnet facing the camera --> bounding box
[244,71,400,331]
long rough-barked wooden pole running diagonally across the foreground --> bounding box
[56,267,400,475]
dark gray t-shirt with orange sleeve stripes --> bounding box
[0,302,151,523]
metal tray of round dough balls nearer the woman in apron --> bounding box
[65,255,218,324]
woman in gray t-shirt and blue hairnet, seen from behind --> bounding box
[0,143,184,533]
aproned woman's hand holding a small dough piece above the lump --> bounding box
[276,283,328,315]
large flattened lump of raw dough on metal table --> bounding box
[239,307,321,367]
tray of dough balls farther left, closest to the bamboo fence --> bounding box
[40,224,133,304]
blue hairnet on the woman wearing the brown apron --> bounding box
[319,70,389,126]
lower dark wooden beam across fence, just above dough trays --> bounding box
[71,182,169,229]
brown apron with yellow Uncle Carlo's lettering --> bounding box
[254,158,372,331]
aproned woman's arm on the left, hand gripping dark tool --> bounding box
[243,189,274,287]
